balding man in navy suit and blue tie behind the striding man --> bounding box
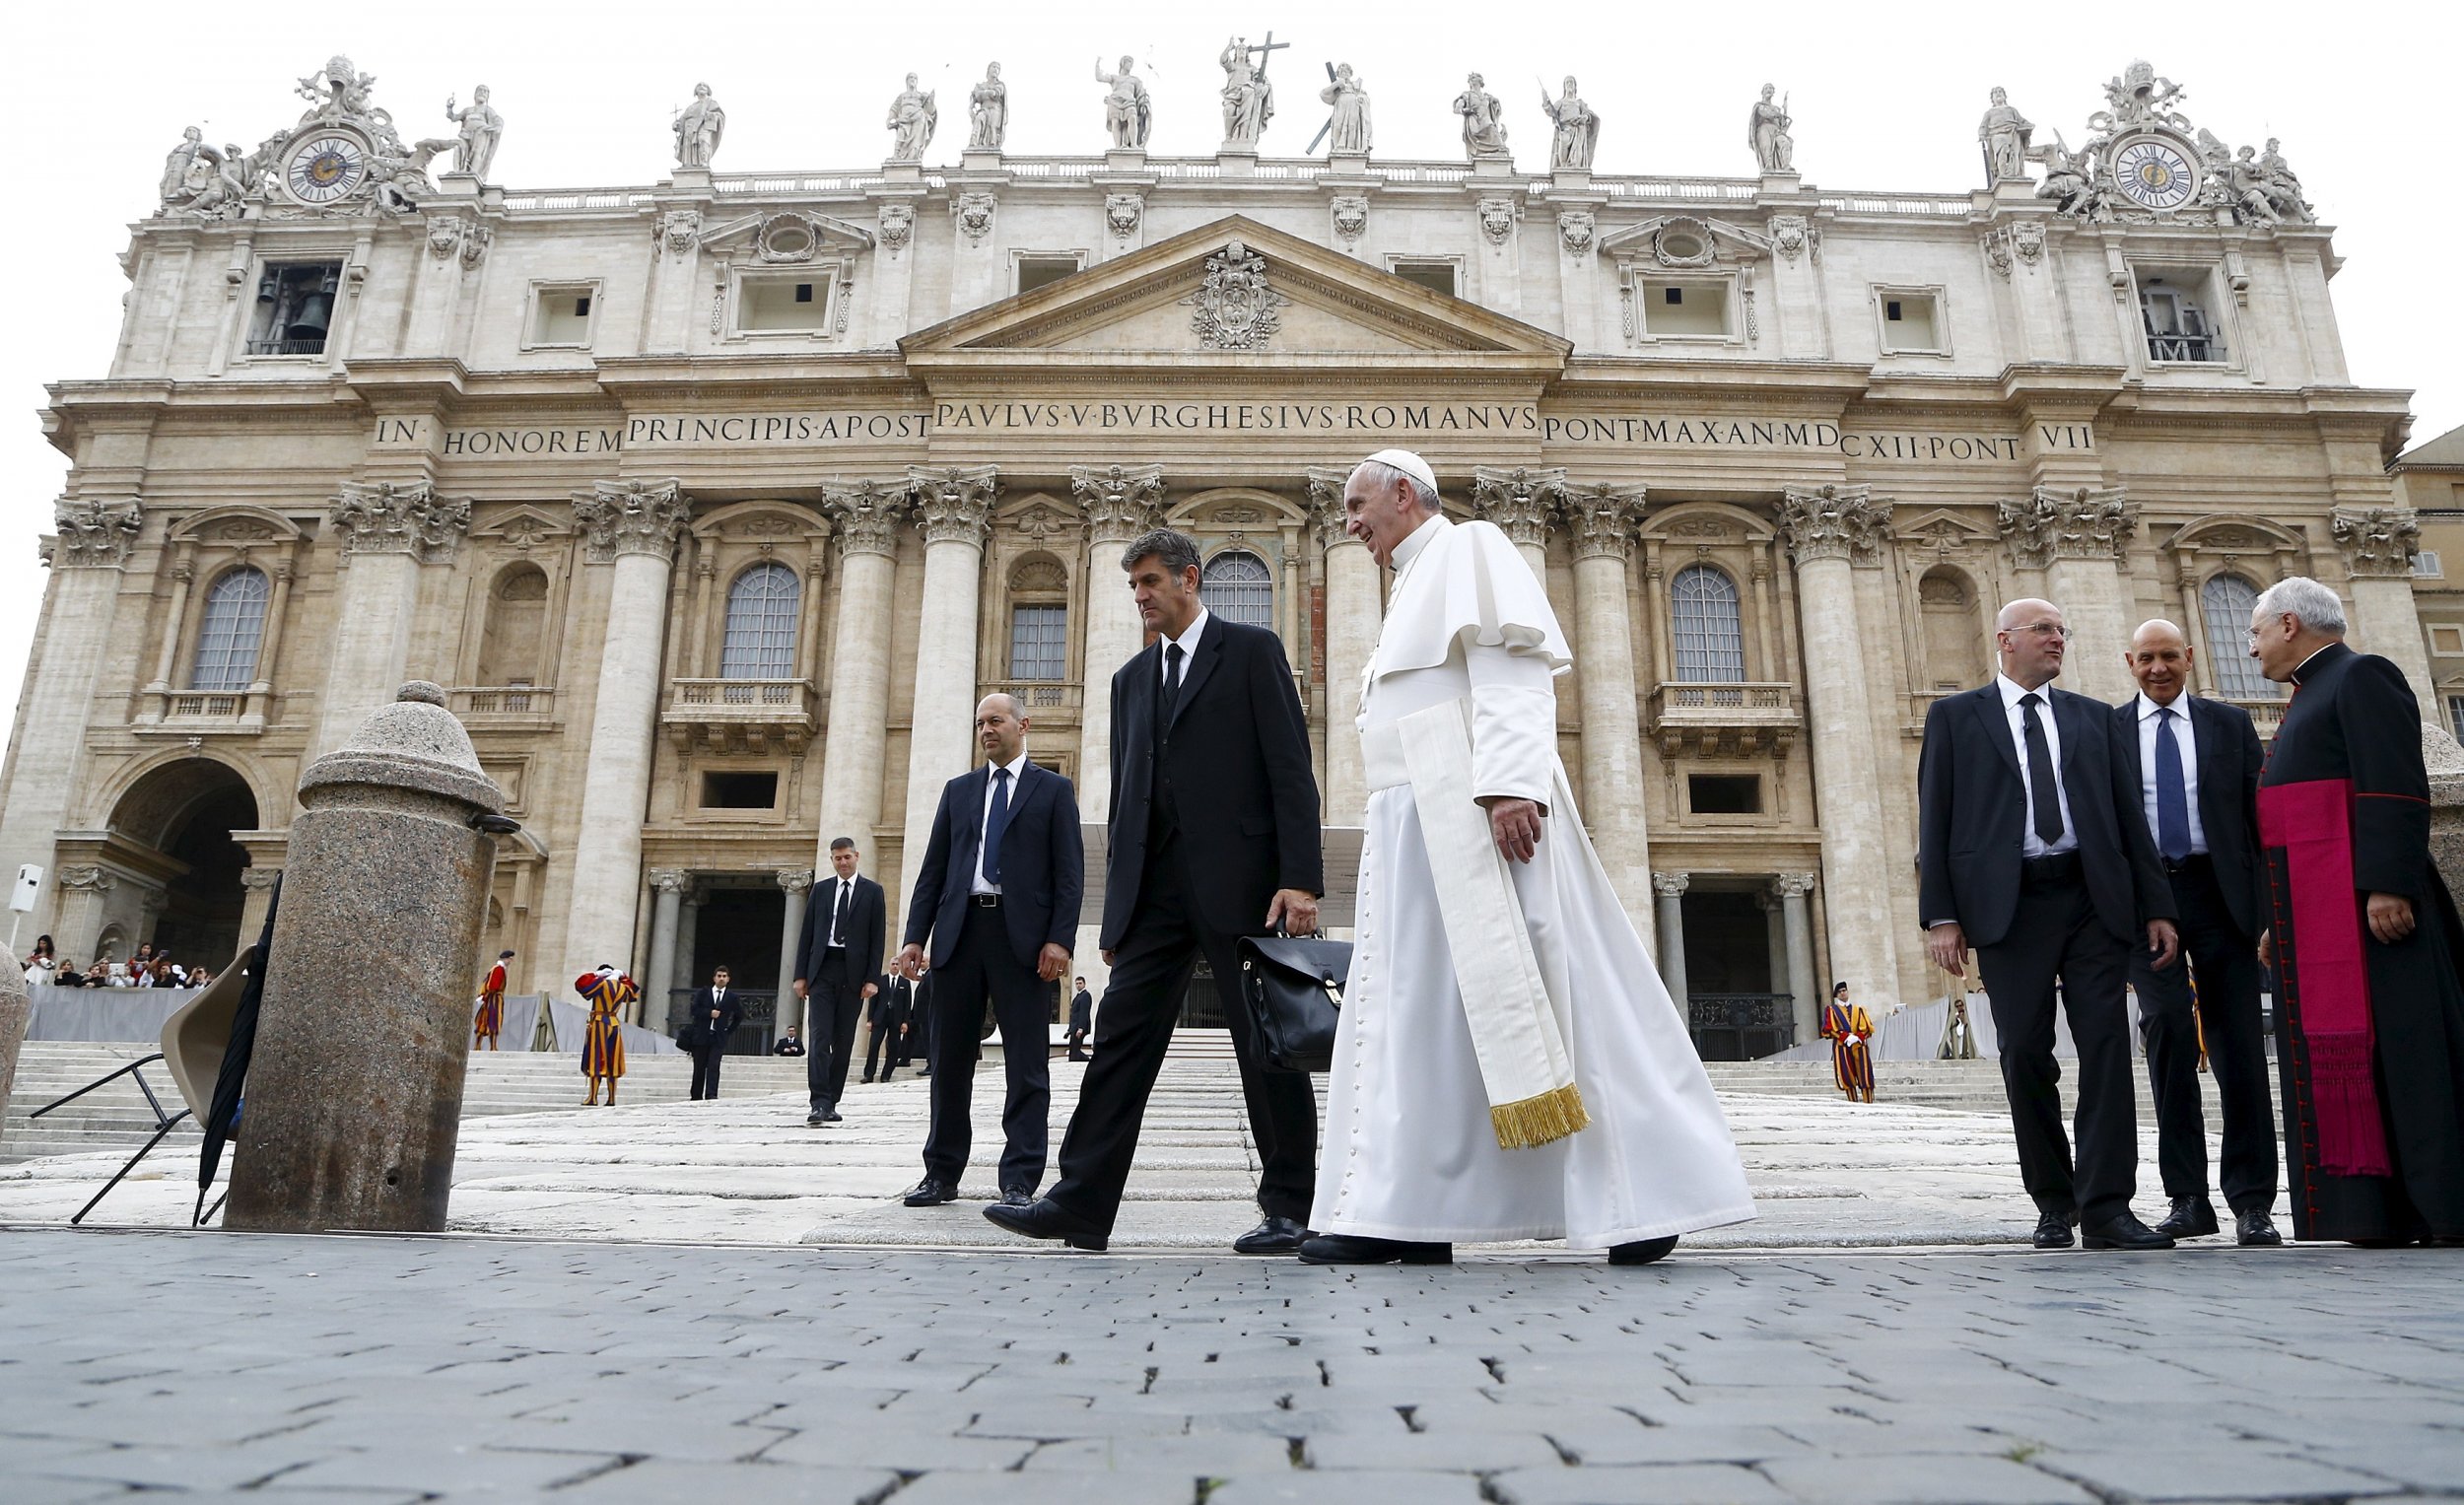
[892,695,1087,1207]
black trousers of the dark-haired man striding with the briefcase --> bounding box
[1053,840,1319,1234]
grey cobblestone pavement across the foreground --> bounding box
[0,1227,2464,1505]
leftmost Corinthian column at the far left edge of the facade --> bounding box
[0,498,146,940]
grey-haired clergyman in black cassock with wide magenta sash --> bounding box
[2252,577,2464,1244]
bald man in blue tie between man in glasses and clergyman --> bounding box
[2114,618,2285,1244]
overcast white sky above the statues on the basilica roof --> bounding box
[0,0,2464,728]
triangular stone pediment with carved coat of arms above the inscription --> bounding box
[900,214,1572,370]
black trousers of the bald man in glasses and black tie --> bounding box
[1976,867,2139,1227]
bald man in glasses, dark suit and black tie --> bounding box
[1917,601,2181,1249]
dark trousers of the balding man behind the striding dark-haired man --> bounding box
[924,904,1053,1195]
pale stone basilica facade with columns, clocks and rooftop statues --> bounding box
[0,49,2432,1057]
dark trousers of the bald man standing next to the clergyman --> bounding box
[2132,857,2277,1212]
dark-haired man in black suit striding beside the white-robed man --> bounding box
[984,527,1326,1254]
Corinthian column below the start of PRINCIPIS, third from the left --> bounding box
[565,480,693,1000]
